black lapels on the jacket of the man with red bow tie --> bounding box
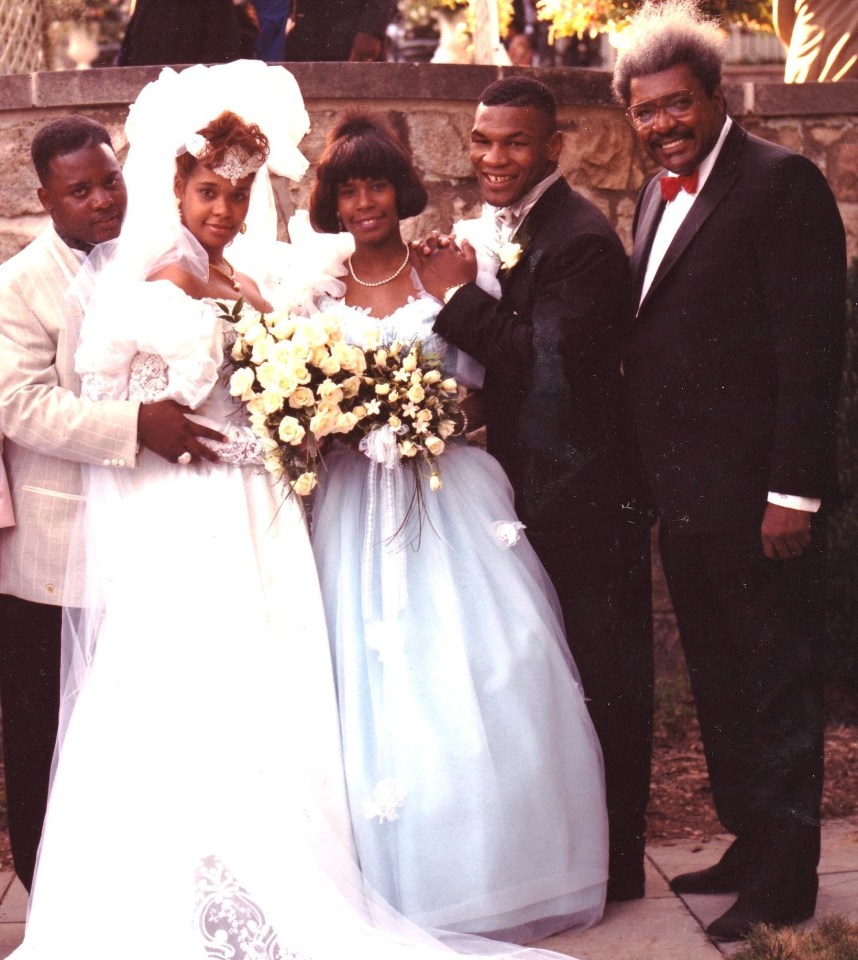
[632,122,747,307]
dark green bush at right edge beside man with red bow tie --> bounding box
[828,259,858,688]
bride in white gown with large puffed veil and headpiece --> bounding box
[15,63,580,960]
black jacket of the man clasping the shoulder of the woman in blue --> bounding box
[435,180,644,542]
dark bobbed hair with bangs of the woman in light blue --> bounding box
[310,112,429,233]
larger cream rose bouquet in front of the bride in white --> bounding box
[219,300,367,497]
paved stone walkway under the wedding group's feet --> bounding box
[0,820,858,960]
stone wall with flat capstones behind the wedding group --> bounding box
[0,63,858,260]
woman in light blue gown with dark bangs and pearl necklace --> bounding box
[310,115,607,942]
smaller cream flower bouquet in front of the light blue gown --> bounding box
[353,331,463,490]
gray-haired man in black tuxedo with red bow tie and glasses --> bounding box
[614,0,846,940]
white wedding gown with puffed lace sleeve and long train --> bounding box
[14,281,576,960]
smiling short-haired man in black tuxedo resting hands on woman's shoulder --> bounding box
[415,77,653,900]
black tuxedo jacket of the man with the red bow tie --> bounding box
[624,123,846,533]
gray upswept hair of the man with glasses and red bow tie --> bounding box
[613,0,726,104]
